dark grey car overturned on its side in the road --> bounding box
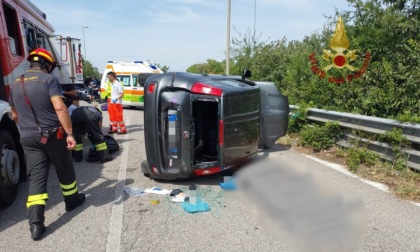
[141,71,289,180]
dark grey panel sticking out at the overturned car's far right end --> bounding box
[256,82,289,149]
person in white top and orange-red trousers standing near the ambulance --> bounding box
[106,72,127,134]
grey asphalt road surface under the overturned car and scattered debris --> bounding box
[0,102,420,252]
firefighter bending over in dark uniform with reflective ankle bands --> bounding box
[69,105,113,163]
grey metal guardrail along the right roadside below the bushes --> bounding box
[289,105,420,172]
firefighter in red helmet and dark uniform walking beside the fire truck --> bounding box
[9,48,85,240]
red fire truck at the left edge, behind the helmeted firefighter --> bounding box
[0,0,83,207]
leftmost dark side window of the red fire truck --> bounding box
[3,3,23,56]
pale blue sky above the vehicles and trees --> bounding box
[31,0,350,72]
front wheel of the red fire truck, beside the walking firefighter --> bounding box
[0,130,20,207]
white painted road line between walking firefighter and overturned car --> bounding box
[106,130,129,252]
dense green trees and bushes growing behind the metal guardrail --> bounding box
[182,0,420,118]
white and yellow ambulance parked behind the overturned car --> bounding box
[100,60,163,107]
